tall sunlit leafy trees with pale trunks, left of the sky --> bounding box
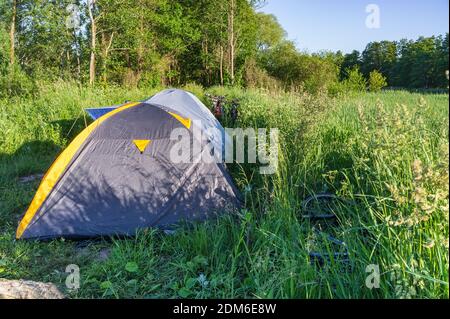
[0,0,264,89]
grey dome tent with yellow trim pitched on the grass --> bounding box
[16,90,240,239]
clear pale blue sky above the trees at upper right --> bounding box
[260,0,449,53]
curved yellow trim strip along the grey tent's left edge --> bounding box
[16,102,141,239]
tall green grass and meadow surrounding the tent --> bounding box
[0,83,449,298]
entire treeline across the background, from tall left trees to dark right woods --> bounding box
[0,0,449,95]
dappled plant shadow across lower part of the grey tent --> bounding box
[19,158,239,240]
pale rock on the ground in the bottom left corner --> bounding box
[0,279,65,299]
